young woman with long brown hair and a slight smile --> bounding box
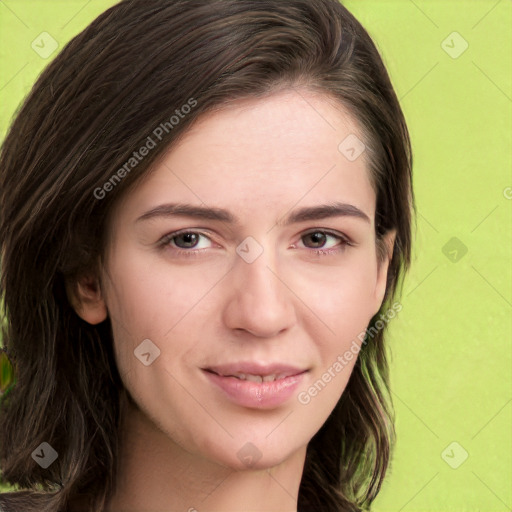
[0,0,414,512]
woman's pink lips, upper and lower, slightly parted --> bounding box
[202,362,308,409]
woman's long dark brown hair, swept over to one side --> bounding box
[0,0,414,512]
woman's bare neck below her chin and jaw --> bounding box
[106,396,306,512]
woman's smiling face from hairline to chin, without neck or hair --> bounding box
[94,91,394,469]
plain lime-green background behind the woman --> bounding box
[0,0,512,512]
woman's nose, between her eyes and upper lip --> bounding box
[223,245,296,338]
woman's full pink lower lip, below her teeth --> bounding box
[203,370,306,409]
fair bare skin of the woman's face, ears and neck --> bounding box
[70,90,395,512]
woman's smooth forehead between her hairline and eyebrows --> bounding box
[113,90,375,226]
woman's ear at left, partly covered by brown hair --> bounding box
[66,275,107,325]
